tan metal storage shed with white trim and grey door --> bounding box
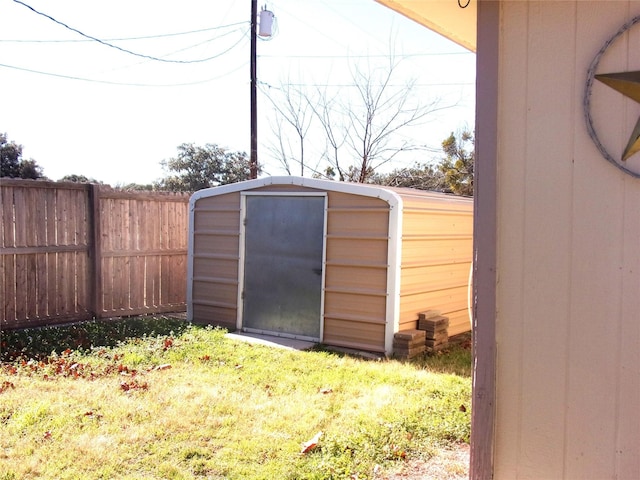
[187,176,473,355]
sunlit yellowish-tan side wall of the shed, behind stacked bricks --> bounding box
[400,196,473,335]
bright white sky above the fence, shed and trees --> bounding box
[0,0,475,185]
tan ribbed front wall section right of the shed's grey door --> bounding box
[324,192,389,351]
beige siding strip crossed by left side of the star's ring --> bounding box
[566,2,640,479]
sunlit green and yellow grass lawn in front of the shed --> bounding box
[0,318,471,480]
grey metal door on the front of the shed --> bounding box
[242,195,325,340]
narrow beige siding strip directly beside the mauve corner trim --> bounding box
[492,2,528,479]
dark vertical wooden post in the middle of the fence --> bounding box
[88,183,103,318]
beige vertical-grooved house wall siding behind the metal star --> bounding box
[496,0,640,479]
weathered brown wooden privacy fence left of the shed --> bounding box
[0,179,189,329]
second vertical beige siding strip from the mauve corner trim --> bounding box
[520,2,580,479]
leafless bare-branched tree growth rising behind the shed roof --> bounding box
[262,51,450,183]
